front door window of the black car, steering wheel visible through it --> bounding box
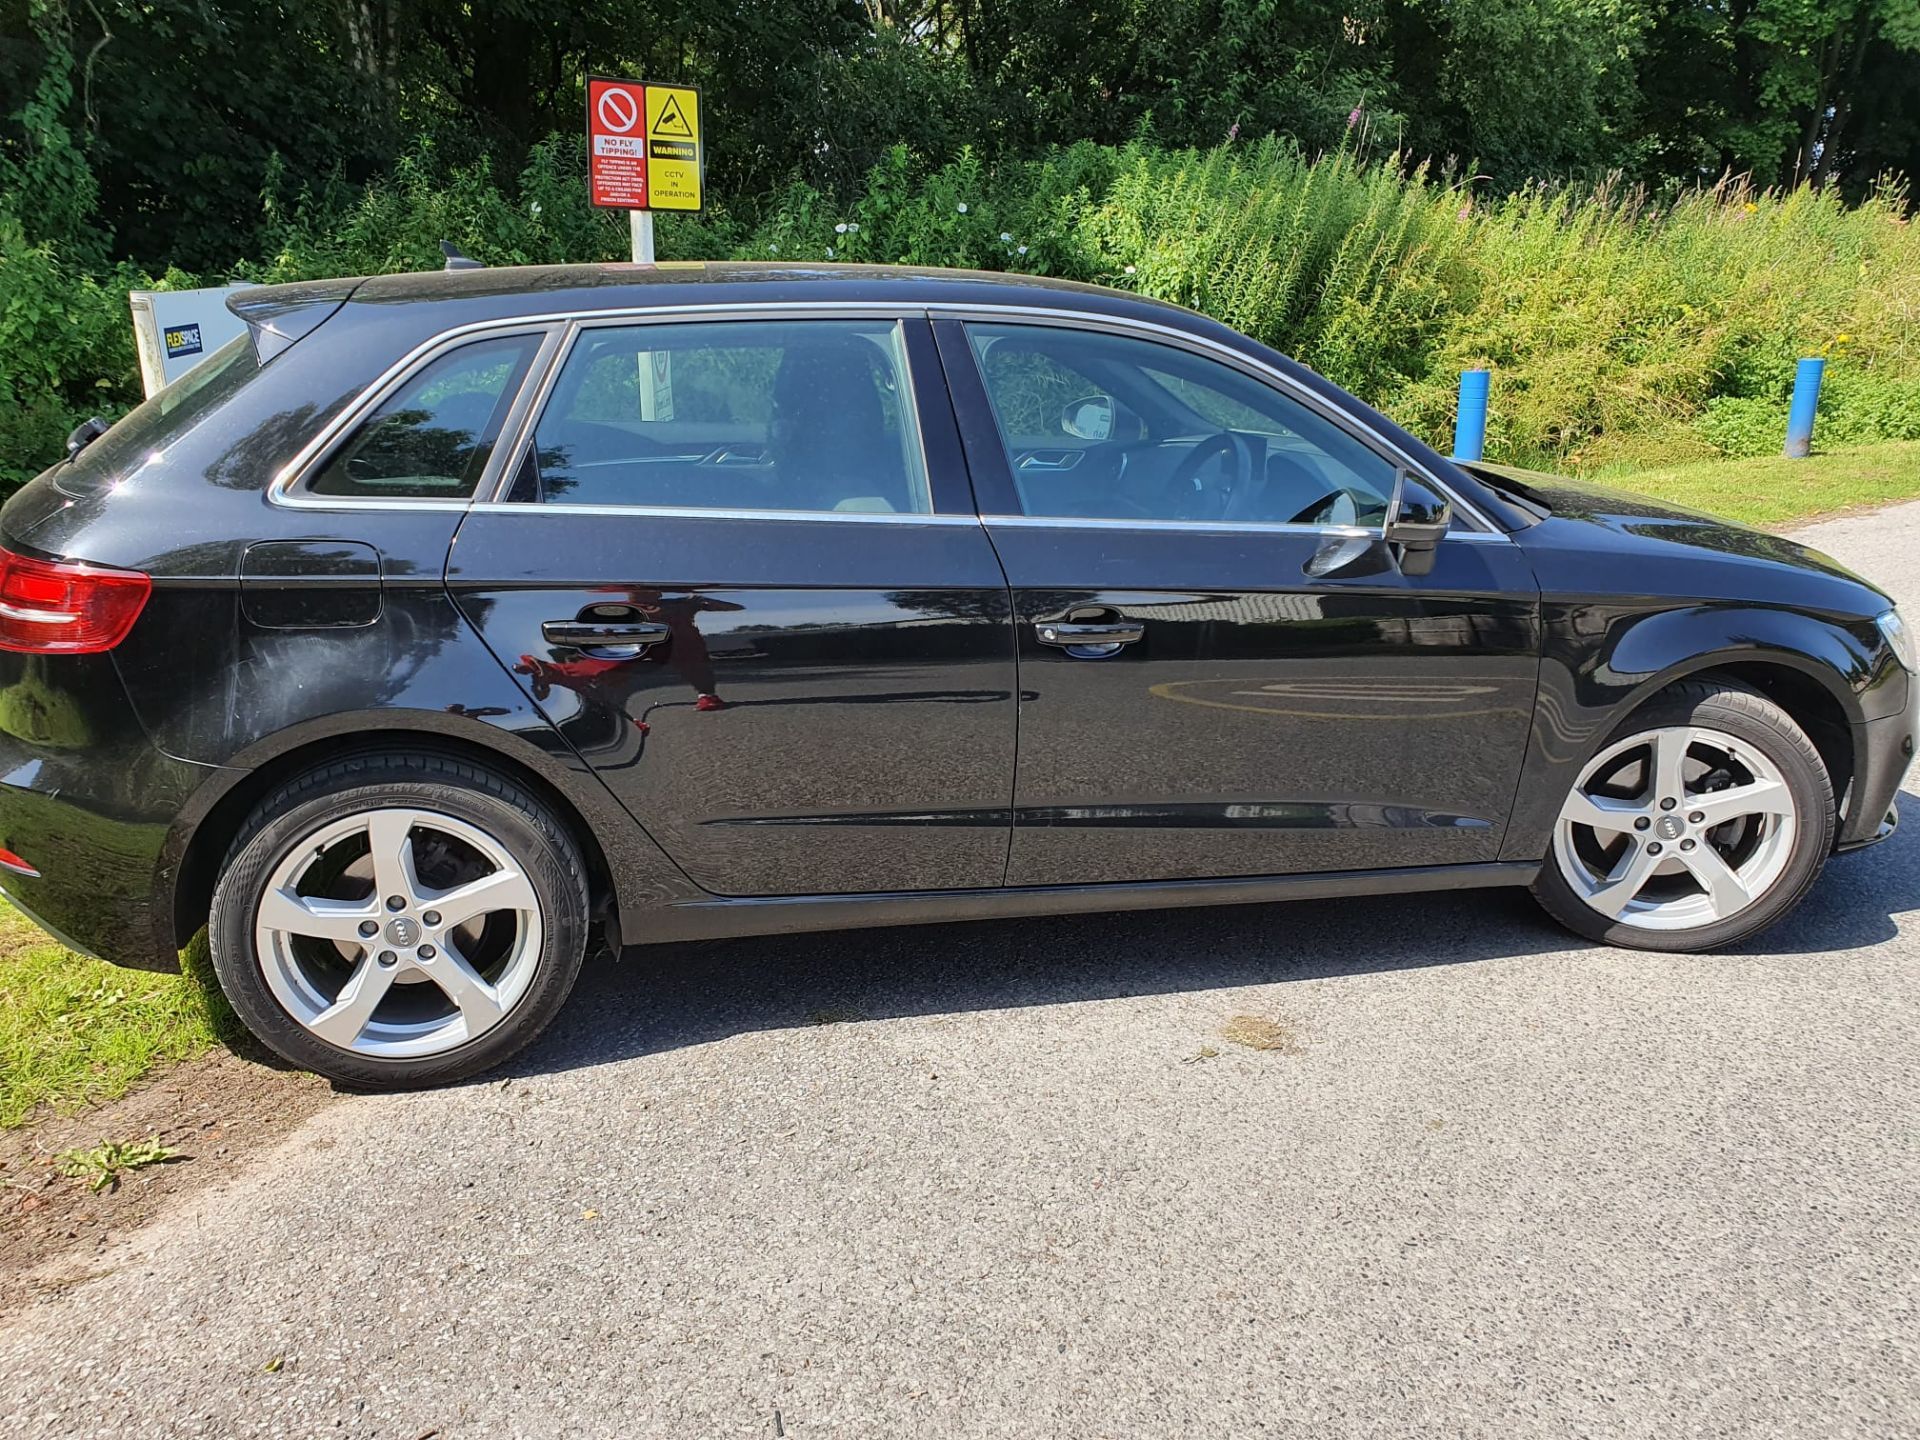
[966,324,1396,528]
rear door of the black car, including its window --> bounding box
[447,309,1016,895]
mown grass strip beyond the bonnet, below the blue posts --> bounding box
[1594,440,1920,526]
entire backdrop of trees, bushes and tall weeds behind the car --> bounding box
[0,0,1920,484]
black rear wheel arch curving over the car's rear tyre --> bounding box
[154,710,660,948]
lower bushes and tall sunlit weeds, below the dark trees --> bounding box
[0,136,1920,484]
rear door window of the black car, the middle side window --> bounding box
[511,321,933,515]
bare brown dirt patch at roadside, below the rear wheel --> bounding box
[0,1050,334,1315]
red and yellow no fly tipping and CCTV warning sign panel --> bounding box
[588,79,705,209]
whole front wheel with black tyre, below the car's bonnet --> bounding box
[1534,682,1836,950]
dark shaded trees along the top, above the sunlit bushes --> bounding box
[0,0,1920,271]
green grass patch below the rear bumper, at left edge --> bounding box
[0,902,215,1129]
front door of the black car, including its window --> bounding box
[937,321,1538,885]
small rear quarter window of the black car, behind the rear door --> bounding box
[309,334,540,499]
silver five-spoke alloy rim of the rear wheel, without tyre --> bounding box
[253,808,541,1060]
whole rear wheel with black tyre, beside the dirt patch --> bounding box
[207,753,588,1089]
